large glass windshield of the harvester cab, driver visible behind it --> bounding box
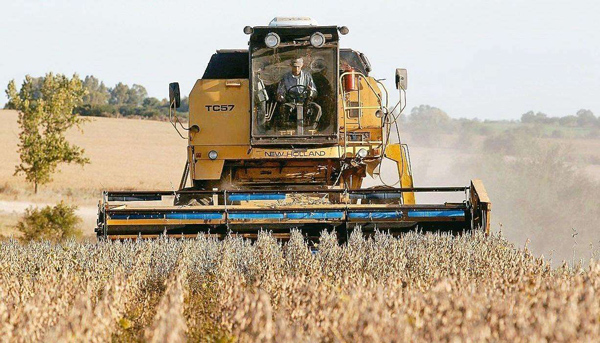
[251,42,337,138]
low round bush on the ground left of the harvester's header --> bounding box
[17,201,82,241]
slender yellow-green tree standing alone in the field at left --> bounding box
[6,73,89,193]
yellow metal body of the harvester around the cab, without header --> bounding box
[188,73,414,195]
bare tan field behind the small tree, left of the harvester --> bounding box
[0,110,187,205]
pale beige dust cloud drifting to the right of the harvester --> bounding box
[364,133,600,265]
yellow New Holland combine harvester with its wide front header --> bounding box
[96,18,491,240]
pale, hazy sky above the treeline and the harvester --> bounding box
[0,0,600,119]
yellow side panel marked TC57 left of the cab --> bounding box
[190,79,250,145]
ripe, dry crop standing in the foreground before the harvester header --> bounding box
[0,232,600,342]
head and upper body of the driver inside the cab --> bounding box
[277,58,317,102]
